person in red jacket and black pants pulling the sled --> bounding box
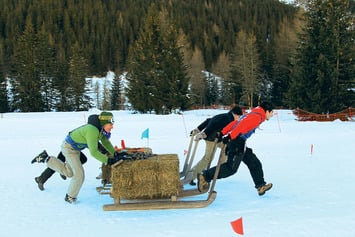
[197,102,273,196]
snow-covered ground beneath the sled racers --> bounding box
[0,110,355,237]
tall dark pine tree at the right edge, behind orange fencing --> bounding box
[290,0,355,113]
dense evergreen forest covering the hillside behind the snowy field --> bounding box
[0,0,355,114]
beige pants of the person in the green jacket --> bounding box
[47,141,85,198]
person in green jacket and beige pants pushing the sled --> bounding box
[31,111,127,203]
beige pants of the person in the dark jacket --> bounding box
[191,141,227,180]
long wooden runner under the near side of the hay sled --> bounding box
[103,191,217,211]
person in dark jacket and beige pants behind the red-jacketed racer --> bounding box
[188,106,243,185]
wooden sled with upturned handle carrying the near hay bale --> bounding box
[103,146,222,211]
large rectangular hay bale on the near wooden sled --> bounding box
[111,154,180,199]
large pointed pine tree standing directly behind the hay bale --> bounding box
[127,5,188,114]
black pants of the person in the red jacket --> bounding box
[203,137,266,188]
